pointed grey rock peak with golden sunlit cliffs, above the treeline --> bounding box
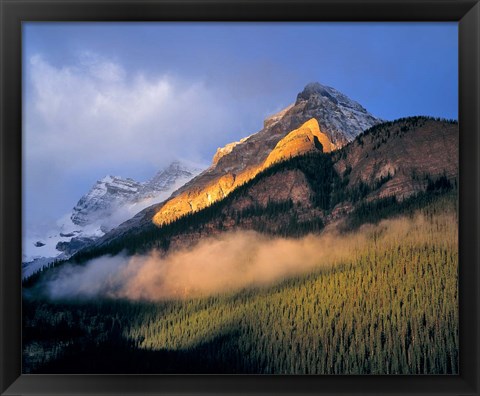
[145,83,381,225]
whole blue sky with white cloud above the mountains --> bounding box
[23,22,458,227]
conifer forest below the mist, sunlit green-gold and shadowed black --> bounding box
[23,192,459,374]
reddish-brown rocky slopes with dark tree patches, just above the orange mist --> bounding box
[155,118,458,254]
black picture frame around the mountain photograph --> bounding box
[0,0,480,396]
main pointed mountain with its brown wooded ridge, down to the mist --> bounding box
[26,83,458,276]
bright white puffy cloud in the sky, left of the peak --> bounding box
[25,53,231,169]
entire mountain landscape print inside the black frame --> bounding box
[18,22,459,375]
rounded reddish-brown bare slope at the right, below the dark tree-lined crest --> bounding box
[335,117,459,199]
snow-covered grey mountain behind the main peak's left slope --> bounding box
[22,161,200,276]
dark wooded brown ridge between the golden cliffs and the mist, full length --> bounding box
[71,117,458,261]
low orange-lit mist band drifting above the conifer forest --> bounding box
[47,231,365,301]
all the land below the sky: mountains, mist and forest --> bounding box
[22,83,459,375]
